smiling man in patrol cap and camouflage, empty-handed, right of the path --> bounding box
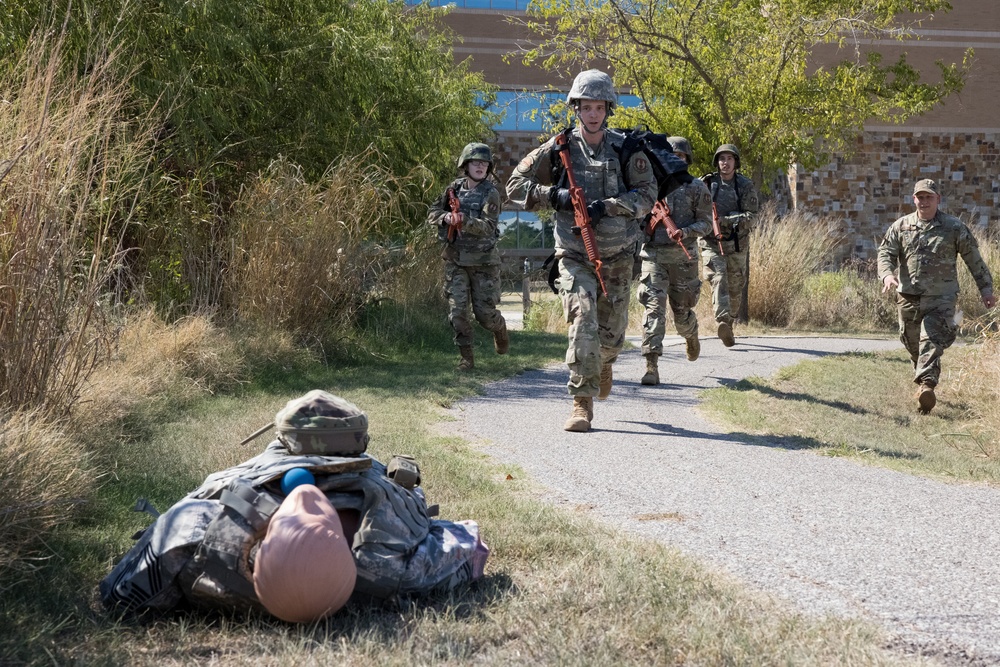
[878,178,996,414]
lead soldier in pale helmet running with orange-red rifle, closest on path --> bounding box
[507,70,657,431]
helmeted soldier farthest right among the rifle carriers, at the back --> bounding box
[698,144,760,347]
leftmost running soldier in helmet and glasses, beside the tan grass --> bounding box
[427,143,510,371]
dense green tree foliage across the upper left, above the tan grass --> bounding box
[0,0,488,193]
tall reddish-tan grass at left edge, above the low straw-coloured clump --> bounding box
[0,32,148,414]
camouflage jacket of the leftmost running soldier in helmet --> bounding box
[427,178,500,266]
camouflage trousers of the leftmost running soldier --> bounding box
[444,261,504,346]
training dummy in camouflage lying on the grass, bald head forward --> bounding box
[100,390,489,622]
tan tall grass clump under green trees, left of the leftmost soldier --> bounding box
[225,158,428,338]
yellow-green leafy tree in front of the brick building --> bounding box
[525,0,972,185]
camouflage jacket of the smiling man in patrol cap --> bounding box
[878,211,993,296]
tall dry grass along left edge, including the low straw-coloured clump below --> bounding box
[0,28,149,579]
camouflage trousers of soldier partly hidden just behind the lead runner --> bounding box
[637,245,701,355]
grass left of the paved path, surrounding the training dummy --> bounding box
[0,316,917,665]
